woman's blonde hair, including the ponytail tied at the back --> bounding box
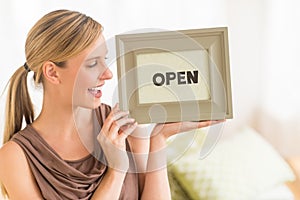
[2,10,103,197]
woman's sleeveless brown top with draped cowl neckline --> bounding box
[12,104,138,200]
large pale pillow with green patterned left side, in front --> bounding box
[169,128,295,200]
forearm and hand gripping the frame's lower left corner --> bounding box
[92,105,137,200]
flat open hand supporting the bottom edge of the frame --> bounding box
[152,120,225,139]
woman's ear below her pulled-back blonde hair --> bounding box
[43,61,60,84]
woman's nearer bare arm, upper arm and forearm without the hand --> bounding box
[0,142,130,200]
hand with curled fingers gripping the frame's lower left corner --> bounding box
[97,104,137,171]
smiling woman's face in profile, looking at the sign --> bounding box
[64,35,112,109]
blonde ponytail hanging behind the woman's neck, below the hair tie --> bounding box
[3,64,34,144]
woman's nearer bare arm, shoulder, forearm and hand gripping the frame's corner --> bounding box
[0,104,136,200]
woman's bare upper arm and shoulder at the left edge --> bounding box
[0,141,43,200]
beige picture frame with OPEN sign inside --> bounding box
[116,27,232,123]
